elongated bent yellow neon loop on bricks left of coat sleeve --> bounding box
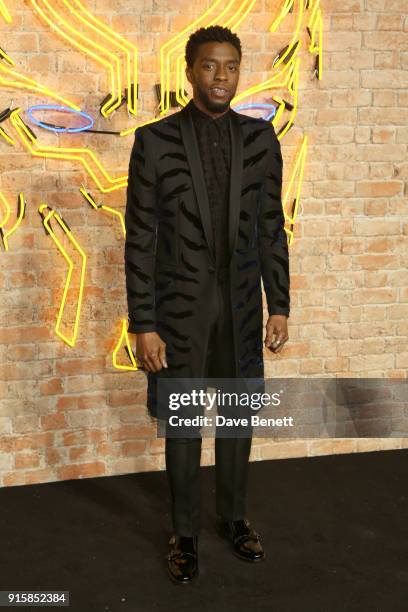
[38,204,86,347]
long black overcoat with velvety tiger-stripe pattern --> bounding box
[124,100,290,415]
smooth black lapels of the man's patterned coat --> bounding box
[178,100,243,263]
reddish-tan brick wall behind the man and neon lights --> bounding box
[0,0,408,486]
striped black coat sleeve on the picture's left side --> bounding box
[124,128,157,333]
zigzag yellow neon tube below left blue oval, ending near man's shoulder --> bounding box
[10,108,127,193]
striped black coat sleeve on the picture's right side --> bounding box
[259,126,290,317]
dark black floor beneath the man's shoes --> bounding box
[0,450,408,612]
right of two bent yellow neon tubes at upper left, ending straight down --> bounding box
[63,0,138,115]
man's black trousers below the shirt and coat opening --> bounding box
[165,270,252,536]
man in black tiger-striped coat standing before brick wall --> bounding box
[125,26,290,583]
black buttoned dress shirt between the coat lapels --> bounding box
[190,100,231,267]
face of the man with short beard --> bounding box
[186,42,239,114]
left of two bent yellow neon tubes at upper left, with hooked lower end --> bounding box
[31,0,122,118]
